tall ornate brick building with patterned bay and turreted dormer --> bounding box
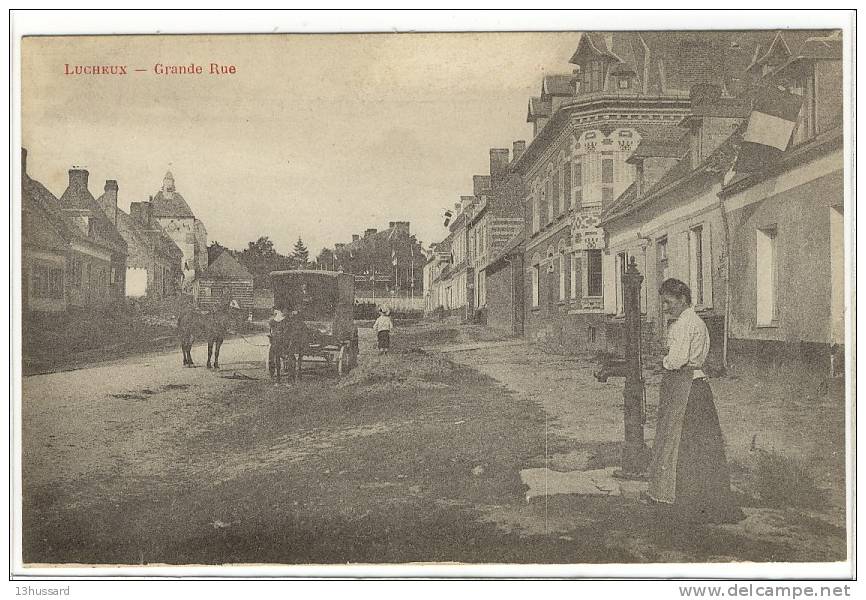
[512,31,820,352]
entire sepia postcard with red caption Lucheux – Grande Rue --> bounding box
[12,11,855,589]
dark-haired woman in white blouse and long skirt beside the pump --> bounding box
[647,279,744,523]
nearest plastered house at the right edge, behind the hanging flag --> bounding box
[720,32,850,374]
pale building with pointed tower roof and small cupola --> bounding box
[151,171,208,292]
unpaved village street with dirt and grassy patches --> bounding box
[22,326,845,564]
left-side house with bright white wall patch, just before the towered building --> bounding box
[97,180,183,298]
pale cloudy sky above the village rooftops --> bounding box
[21,32,579,255]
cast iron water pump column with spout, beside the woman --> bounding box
[595,256,649,479]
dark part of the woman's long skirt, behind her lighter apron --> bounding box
[671,379,744,523]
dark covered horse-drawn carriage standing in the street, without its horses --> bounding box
[270,270,358,377]
